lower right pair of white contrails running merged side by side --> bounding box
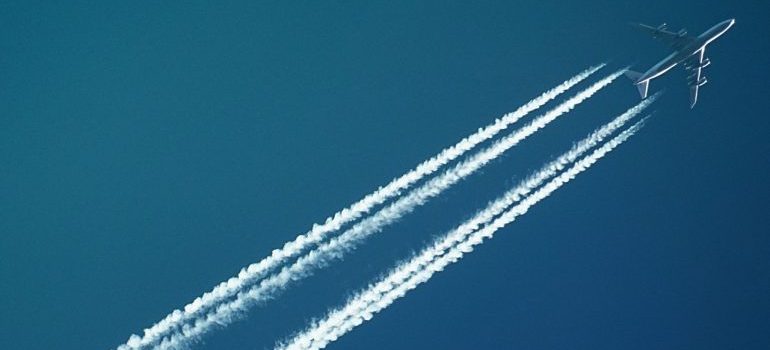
[278,108,656,350]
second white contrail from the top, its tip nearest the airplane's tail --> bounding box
[152,69,625,348]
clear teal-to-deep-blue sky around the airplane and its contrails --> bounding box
[0,0,770,349]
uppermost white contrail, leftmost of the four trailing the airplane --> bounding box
[118,63,605,350]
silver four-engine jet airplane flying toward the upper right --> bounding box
[625,18,735,108]
